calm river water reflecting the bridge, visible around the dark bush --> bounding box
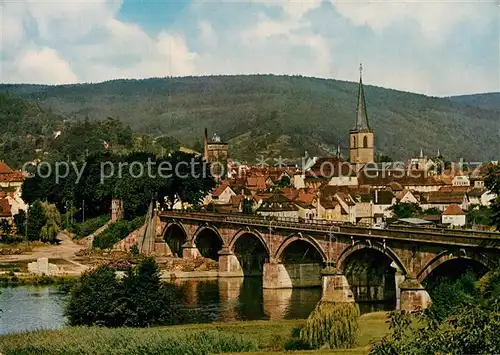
[0,278,388,334]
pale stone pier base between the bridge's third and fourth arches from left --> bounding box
[262,262,322,289]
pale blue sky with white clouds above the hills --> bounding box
[0,0,500,96]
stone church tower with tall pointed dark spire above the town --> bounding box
[349,65,374,164]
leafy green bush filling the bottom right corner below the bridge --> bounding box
[370,271,500,355]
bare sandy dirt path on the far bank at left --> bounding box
[0,233,86,271]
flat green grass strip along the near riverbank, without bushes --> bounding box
[0,312,388,355]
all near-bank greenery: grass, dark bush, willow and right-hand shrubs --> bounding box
[0,258,500,355]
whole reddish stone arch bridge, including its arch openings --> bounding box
[155,211,500,310]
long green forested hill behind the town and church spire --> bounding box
[0,75,500,162]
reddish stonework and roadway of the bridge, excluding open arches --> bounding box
[155,211,500,310]
